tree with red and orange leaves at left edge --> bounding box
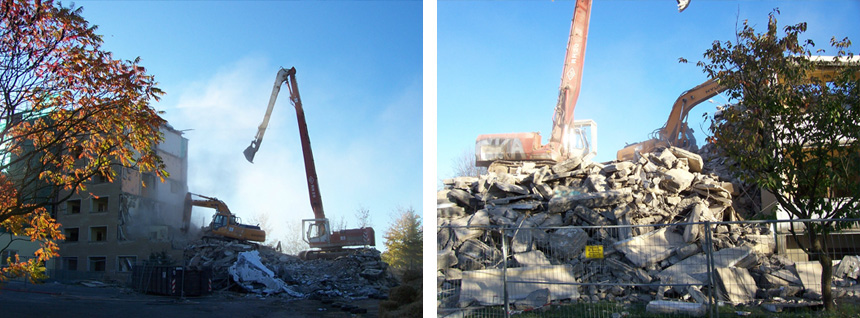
[0,0,166,279]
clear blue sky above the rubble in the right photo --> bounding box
[436,0,860,179]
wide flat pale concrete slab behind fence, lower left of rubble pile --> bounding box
[460,264,579,306]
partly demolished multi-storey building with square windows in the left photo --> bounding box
[51,125,188,281]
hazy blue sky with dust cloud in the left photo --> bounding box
[75,1,423,249]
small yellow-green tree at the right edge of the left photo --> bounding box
[382,207,424,272]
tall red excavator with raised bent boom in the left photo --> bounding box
[244,67,376,260]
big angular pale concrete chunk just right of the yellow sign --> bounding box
[614,227,685,267]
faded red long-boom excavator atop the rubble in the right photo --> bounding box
[475,0,689,172]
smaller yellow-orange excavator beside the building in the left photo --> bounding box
[183,192,266,242]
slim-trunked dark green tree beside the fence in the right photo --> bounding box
[698,10,860,310]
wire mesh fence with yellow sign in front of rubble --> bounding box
[436,219,860,318]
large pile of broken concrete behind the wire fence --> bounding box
[437,148,860,315]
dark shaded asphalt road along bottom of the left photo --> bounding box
[0,282,379,318]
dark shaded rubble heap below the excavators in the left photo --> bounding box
[185,240,397,299]
